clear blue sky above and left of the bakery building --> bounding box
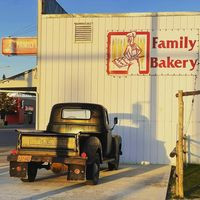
[0,0,200,79]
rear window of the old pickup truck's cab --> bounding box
[62,109,91,119]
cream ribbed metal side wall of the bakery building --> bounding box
[39,13,200,163]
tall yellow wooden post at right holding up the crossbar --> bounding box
[178,90,184,198]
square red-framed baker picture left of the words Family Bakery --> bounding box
[107,31,150,74]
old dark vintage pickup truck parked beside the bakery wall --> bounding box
[7,103,122,185]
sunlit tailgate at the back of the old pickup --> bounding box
[17,130,79,156]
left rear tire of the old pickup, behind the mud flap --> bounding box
[21,162,38,182]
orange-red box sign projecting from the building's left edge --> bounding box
[2,38,37,56]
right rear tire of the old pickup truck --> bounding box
[86,153,100,185]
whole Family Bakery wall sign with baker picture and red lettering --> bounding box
[107,29,199,75]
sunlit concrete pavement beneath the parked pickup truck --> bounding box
[0,148,171,200]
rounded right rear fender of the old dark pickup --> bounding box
[83,136,103,164]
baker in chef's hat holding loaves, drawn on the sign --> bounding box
[113,32,142,71]
